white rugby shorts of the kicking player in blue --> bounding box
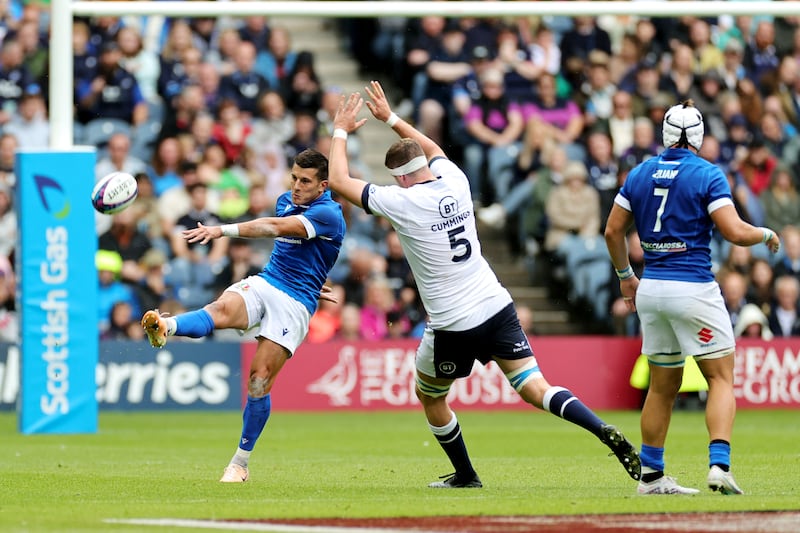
[225,276,311,357]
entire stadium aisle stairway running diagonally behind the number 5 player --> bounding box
[282,17,581,335]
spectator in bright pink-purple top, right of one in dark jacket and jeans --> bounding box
[522,73,586,161]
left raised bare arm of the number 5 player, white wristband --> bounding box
[328,93,367,207]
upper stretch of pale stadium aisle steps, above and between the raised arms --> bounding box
[282,17,404,184]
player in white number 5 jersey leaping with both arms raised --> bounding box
[329,81,641,488]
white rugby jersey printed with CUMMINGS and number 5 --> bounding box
[361,157,511,331]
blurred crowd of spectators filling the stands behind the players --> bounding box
[0,5,800,342]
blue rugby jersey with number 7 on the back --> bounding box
[614,148,733,282]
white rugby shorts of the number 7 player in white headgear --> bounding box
[636,279,736,367]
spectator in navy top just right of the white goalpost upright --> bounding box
[77,41,148,126]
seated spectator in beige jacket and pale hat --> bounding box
[544,161,601,252]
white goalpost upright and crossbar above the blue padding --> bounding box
[49,0,800,149]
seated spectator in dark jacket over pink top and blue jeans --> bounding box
[464,68,524,205]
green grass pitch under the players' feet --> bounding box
[0,410,800,532]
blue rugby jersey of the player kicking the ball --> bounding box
[259,191,345,315]
